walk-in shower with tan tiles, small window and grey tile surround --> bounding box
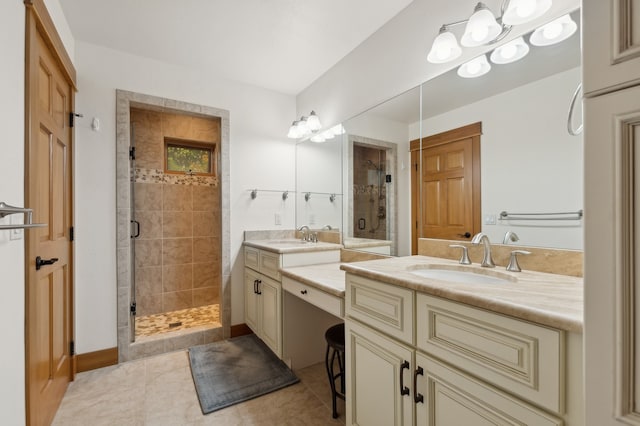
[118,91,230,361]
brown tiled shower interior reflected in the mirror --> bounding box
[353,144,389,240]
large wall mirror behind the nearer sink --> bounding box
[297,11,583,255]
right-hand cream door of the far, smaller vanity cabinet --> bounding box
[258,276,282,358]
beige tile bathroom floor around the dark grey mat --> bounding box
[53,351,345,426]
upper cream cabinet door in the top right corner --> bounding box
[582,0,640,95]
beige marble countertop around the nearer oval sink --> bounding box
[342,256,583,332]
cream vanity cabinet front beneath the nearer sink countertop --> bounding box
[345,273,582,426]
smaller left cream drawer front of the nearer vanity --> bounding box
[345,274,414,344]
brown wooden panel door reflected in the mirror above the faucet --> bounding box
[410,123,482,254]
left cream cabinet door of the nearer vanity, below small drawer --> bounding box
[345,320,414,426]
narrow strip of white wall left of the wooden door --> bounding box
[0,0,28,425]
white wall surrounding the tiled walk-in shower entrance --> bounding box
[76,42,295,353]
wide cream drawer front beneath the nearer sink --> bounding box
[416,294,565,413]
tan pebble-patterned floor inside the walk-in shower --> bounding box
[136,304,222,337]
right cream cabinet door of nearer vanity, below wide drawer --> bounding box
[416,352,563,426]
